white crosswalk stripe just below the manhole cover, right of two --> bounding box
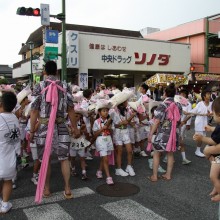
[101,199,166,220]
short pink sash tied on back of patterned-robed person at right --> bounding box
[166,102,180,152]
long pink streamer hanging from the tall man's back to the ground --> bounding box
[35,80,66,203]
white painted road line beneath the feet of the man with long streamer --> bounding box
[11,187,95,209]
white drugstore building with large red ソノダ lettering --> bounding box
[13,21,190,88]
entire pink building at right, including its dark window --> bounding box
[144,14,220,85]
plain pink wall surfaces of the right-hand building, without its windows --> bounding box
[144,18,220,73]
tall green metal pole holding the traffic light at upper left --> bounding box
[61,0,67,81]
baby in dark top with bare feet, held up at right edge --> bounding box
[193,97,220,202]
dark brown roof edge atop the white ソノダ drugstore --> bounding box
[19,22,143,55]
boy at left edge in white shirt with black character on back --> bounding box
[0,92,21,213]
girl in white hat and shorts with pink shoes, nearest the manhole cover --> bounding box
[93,100,114,185]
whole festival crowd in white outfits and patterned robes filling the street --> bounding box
[0,61,220,213]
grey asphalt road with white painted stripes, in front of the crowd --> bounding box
[0,126,218,220]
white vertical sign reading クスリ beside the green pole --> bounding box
[66,31,79,68]
